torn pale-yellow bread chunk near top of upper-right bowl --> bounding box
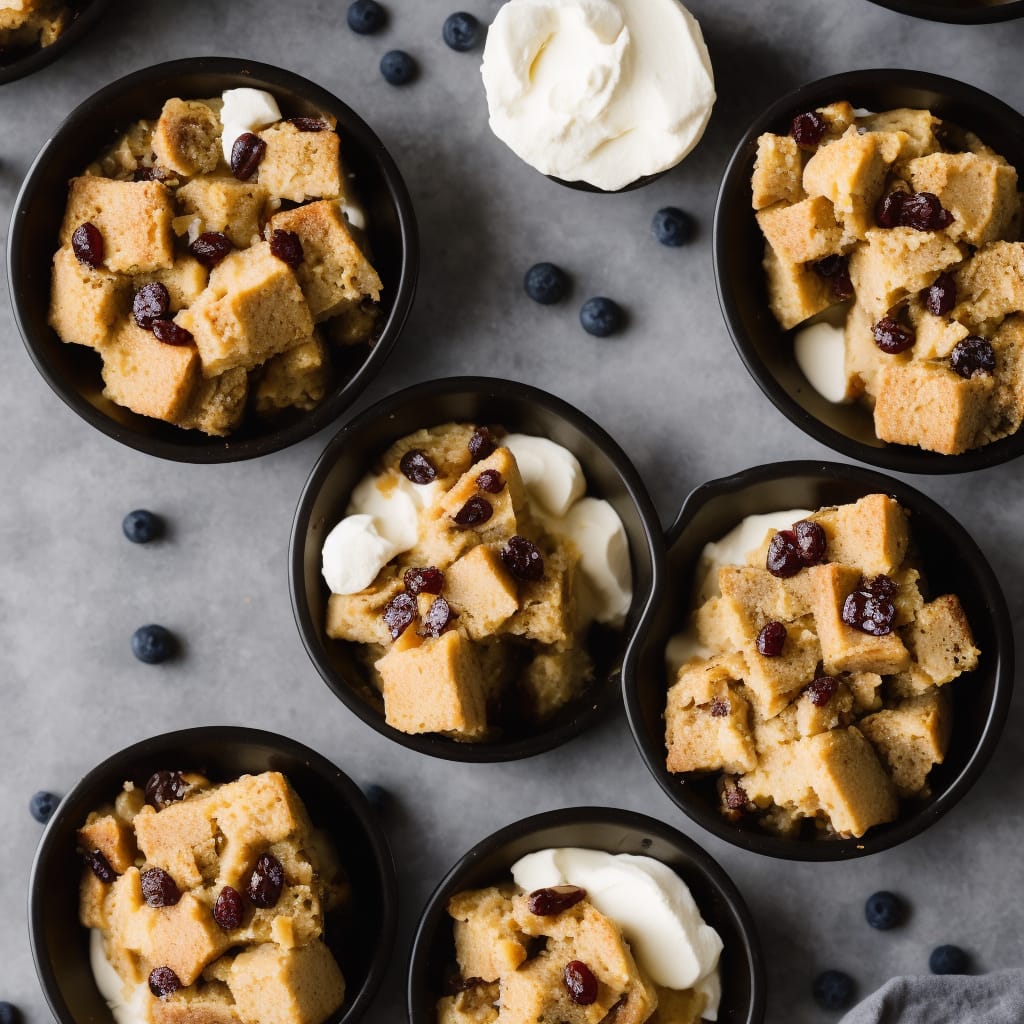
[804,126,888,241]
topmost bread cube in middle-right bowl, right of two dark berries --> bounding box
[808,495,910,577]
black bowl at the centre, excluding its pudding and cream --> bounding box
[289,377,662,762]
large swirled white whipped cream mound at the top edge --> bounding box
[481,0,715,191]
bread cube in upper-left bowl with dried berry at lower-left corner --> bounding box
[60,175,174,273]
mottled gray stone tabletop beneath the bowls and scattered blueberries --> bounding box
[0,0,1024,1024]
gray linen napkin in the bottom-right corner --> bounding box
[841,970,1024,1024]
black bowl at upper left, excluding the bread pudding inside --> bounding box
[7,51,419,463]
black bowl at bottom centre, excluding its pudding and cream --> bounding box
[409,807,765,1024]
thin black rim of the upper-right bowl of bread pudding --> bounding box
[712,68,1024,475]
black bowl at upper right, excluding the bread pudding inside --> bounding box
[714,69,1024,473]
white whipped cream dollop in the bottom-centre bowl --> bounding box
[512,847,722,1020]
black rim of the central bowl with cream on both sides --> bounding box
[288,376,664,764]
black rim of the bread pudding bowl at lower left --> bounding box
[27,725,398,1024]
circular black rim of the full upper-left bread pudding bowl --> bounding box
[7,51,420,465]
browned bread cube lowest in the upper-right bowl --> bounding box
[874,360,995,455]
